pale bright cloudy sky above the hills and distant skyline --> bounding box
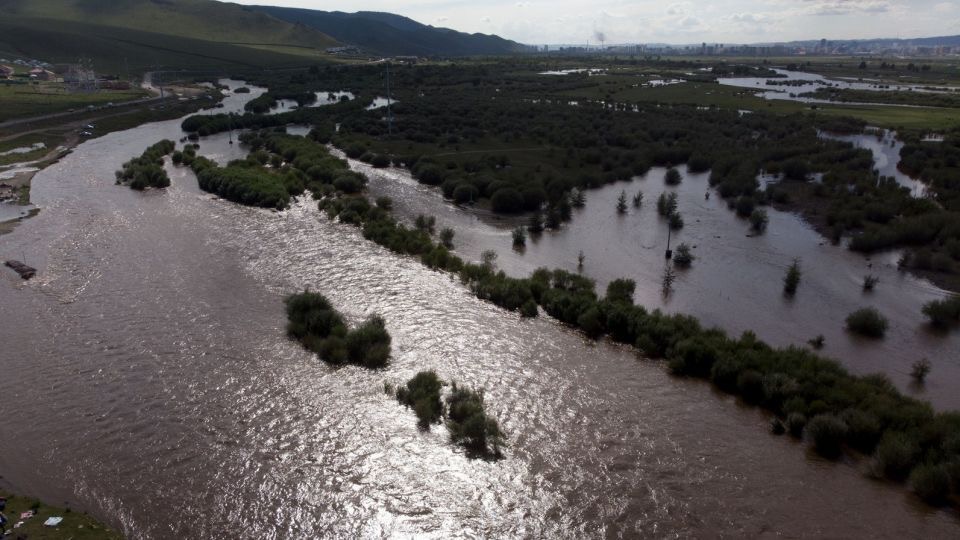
[227,0,960,45]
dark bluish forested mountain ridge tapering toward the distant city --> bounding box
[249,6,528,56]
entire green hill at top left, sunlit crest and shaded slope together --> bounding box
[0,0,337,70]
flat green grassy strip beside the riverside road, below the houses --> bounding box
[0,84,148,122]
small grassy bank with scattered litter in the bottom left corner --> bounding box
[0,492,123,540]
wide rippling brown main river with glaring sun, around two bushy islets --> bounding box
[0,82,960,539]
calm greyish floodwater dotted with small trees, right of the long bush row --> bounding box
[351,156,960,409]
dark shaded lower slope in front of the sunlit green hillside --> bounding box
[0,17,325,74]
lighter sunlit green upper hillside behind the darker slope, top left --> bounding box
[0,0,336,49]
